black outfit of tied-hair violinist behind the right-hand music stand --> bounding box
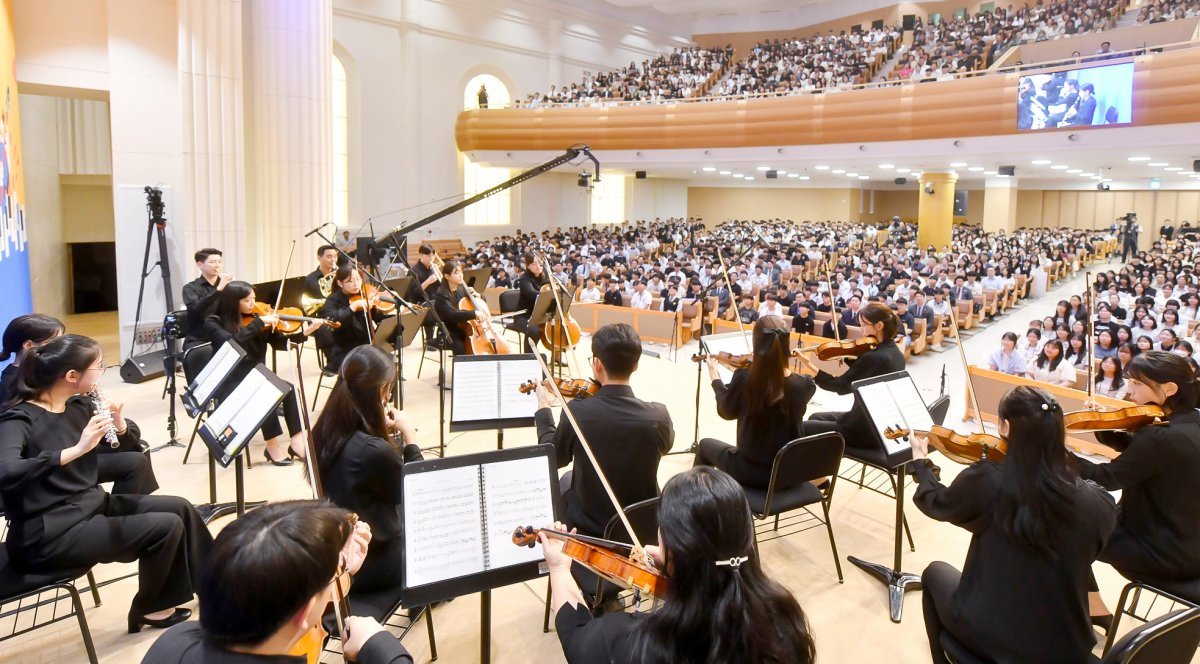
[800,339,904,449]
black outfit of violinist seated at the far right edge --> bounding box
[1075,409,1200,581]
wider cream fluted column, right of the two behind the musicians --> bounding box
[244,0,334,280]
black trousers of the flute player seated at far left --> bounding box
[8,495,212,618]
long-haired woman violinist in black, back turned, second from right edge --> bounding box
[910,385,1116,664]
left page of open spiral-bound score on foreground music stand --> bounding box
[404,466,485,587]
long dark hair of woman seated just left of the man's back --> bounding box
[312,341,396,473]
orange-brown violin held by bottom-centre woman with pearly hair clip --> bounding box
[512,526,667,598]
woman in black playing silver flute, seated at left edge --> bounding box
[0,334,212,634]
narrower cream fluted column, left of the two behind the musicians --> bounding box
[176,0,252,276]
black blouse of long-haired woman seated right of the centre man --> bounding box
[713,369,817,468]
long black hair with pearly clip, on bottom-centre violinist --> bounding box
[632,466,816,664]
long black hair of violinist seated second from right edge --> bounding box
[996,385,1079,558]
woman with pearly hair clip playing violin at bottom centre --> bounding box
[539,467,816,664]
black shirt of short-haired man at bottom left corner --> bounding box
[142,619,413,664]
